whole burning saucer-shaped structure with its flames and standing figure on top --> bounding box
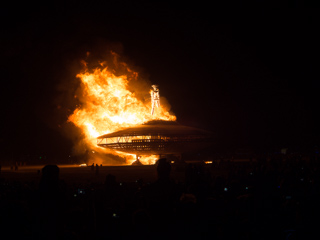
[68,52,210,164]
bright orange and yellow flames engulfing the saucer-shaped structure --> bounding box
[68,53,176,164]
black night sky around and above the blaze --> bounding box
[0,4,320,158]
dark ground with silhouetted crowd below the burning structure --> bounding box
[0,156,320,239]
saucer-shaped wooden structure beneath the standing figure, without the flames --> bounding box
[97,121,212,156]
